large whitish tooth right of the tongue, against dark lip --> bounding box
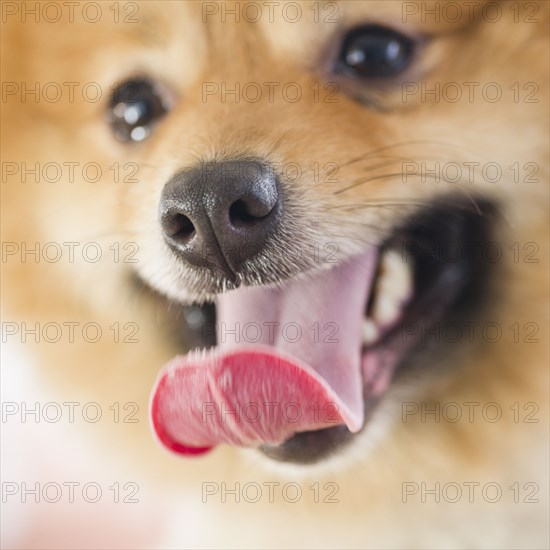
[372,250,413,326]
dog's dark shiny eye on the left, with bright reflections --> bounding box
[108,79,168,146]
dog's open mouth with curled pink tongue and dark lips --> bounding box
[151,197,494,463]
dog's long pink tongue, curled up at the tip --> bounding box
[151,251,376,454]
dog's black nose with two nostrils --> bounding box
[160,160,282,280]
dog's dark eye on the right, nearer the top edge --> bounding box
[337,25,415,78]
